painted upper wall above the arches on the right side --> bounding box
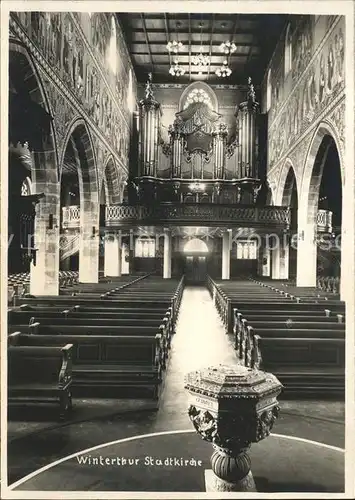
[262,16,345,204]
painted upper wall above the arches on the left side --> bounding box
[10,12,136,192]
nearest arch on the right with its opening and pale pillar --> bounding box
[297,123,343,287]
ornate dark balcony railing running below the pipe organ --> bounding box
[105,203,290,229]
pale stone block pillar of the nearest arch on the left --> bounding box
[30,152,60,295]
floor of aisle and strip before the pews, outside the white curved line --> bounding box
[8,287,344,484]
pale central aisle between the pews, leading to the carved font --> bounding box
[153,286,238,431]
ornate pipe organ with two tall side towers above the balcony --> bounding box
[134,74,262,204]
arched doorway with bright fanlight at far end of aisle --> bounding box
[183,238,209,285]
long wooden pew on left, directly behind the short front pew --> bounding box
[9,332,162,399]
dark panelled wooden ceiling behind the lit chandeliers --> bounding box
[117,12,287,85]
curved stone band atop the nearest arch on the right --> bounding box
[300,121,344,222]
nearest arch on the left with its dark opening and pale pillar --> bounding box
[8,43,59,295]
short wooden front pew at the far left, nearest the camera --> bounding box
[8,339,73,419]
